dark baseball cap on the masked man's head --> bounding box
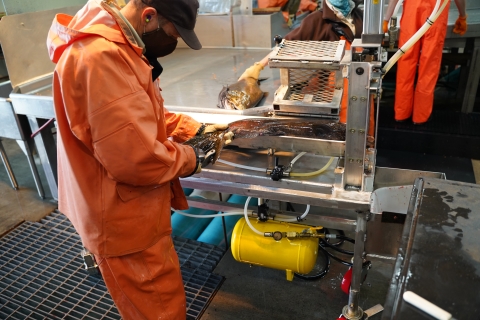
[142,0,202,50]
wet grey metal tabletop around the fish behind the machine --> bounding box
[159,48,280,114]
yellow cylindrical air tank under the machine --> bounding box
[231,218,318,281]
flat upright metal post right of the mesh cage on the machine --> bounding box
[344,62,372,190]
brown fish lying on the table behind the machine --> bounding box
[217,78,265,110]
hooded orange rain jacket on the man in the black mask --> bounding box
[47,0,200,257]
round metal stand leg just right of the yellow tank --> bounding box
[342,212,367,320]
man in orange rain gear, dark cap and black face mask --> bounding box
[47,0,232,319]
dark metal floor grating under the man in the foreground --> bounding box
[0,212,224,319]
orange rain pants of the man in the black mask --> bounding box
[95,235,187,320]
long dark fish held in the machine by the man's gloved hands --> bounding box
[184,118,346,167]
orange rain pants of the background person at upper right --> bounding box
[395,0,450,123]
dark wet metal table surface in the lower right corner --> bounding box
[383,178,480,319]
